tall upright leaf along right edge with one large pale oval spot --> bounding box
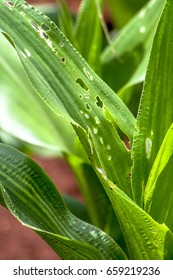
[132,1,173,205]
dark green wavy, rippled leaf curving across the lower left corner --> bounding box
[0,144,125,259]
